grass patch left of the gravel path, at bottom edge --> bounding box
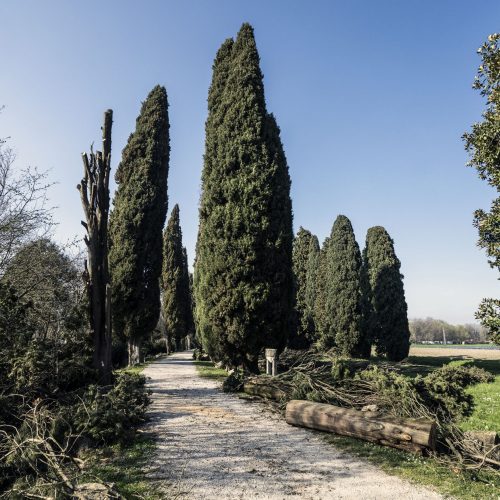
[82,434,161,500]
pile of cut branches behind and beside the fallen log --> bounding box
[245,352,500,470]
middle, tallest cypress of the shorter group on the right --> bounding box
[320,215,362,356]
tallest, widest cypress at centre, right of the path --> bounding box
[195,24,293,370]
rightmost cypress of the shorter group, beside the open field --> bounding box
[363,226,410,361]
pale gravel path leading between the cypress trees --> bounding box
[144,352,441,500]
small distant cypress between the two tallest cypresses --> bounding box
[161,205,191,345]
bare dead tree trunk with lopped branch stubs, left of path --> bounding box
[77,109,113,384]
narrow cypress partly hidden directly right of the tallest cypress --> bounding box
[288,227,313,349]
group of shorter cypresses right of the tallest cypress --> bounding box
[290,215,410,361]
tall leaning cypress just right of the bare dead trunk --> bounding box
[109,85,170,364]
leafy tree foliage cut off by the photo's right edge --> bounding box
[463,33,500,344]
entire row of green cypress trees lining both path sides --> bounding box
[109,24,409,371]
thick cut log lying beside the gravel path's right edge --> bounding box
[285,400,436,454]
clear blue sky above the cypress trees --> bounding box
[0,0,500,322]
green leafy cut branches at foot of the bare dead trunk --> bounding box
[74,372,150,444]
